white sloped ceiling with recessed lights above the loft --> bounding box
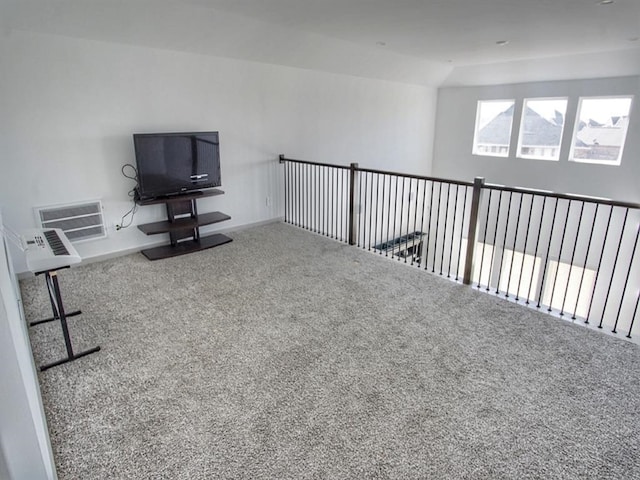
[0,0,640,86]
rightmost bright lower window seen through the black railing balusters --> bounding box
[542,260,596,318]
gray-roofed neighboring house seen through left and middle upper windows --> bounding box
[476,106,564,158]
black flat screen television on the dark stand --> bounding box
[133,132,222,200]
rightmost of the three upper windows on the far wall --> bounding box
[569,96,633,165]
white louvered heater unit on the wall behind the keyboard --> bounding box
[34,200,107,242]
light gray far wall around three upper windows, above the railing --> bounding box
[433,76,640,202]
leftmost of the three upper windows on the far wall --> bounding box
[473,100,515,157]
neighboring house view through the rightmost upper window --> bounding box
[573,116,629,161]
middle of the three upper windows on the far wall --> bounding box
[518,98,567,160]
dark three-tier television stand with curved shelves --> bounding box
[138,189,231,260]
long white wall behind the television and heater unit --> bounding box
[0,31,436,271]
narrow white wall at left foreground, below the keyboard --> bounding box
[0,212,56,480]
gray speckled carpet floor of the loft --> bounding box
[21,224,640,480]
